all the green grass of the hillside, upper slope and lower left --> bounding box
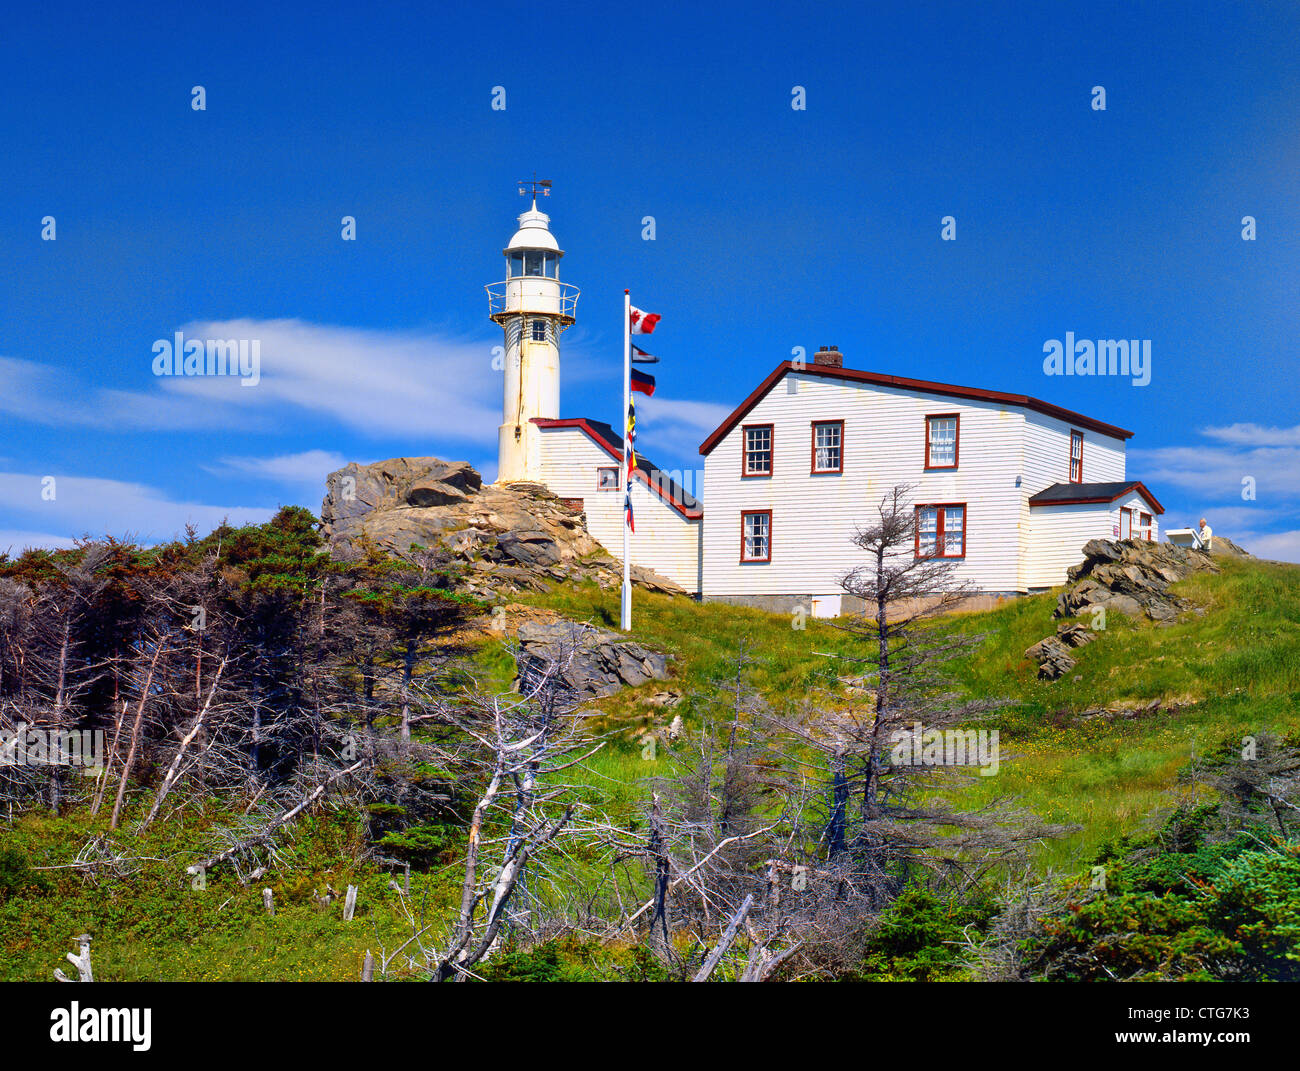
[0,551,1300,980]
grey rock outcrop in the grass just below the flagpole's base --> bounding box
[516,620,668,702]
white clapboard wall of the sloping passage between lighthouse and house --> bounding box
[541,428,701,594]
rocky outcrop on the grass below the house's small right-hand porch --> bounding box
[1053,539,1235,621]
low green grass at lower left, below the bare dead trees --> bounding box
[0,812,467,981]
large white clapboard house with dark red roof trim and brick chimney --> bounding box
[699,348,1162,616]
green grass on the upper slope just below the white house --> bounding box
[520,559,1300,868]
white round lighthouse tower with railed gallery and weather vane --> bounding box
[488,181,579,484]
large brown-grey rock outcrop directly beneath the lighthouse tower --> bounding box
[321,458,685,600]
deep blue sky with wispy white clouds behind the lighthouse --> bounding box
[0,3,1300,560]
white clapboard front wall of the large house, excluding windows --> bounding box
[703,372,1029,597]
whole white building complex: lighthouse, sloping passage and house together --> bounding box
[488,200,1162,616]
